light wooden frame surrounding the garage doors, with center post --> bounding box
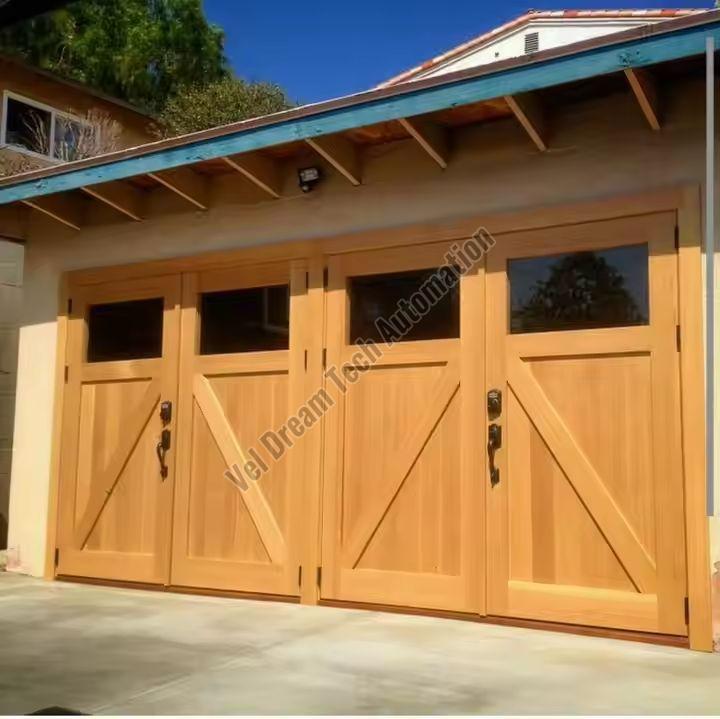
[45,184,712,651]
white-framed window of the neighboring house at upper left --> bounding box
[0,93,92,162]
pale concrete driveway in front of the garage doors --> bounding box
[0,573,720,714]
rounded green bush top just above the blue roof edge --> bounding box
[159,77,292,137]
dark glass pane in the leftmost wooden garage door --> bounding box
[87,297,164,362]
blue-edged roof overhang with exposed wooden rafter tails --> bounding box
[0,11,720,231]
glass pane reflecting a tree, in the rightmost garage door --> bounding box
[508,245,650,333]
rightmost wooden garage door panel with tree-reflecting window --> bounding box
[487,214,687,635]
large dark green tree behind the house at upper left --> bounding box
[0,0,231,112]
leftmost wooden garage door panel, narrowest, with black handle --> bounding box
[57,276,180,583]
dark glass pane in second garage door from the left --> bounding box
[200,285,290,355]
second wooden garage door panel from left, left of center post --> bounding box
[172,263,306,595]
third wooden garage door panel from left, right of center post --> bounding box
[321,245,484,611]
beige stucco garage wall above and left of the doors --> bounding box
[4,83,720,640]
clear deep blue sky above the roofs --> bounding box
[204,0,711,103]
